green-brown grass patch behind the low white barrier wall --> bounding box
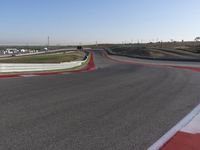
[0,52,84,63]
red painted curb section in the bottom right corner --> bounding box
[161,132,200,150]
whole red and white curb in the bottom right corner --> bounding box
[148,105,200,150]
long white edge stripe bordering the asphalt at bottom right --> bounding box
[148,104,200,150]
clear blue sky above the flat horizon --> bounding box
[0,0,200,44]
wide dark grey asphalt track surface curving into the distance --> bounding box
[0,51,200,150]
